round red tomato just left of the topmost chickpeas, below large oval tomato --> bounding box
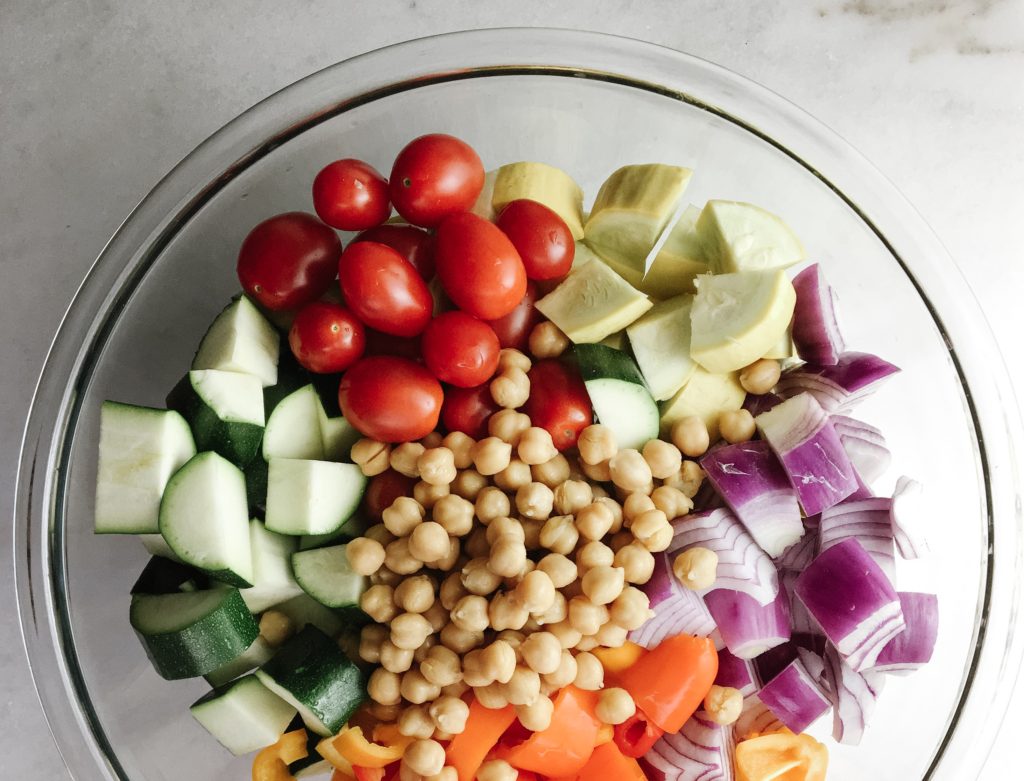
[422,311,501,388]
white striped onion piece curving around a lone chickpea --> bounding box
[670,508,778,605]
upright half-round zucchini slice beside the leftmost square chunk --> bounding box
[160,452,253,589]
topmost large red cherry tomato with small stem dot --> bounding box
[390,133,483,228]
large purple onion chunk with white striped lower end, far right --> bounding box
[796,537,905,672]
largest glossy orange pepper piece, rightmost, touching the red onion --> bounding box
[618,635,718,733]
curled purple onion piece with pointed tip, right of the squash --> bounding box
[775,352,899,414]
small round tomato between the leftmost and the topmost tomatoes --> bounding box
[313,158,391,230]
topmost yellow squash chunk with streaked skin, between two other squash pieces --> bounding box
[585,164,692,272]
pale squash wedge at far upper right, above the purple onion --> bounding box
[696,201,805,273]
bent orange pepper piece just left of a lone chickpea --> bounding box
[501,686,601,778]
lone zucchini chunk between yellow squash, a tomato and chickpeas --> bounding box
[574,344,658,448]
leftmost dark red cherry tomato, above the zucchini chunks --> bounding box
[238,212,341,311]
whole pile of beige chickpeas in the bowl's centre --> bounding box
[331,337,777,781]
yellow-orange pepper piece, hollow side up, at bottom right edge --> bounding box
[736,730,828,781]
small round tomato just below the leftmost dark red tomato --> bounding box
[288,301,367,375]
